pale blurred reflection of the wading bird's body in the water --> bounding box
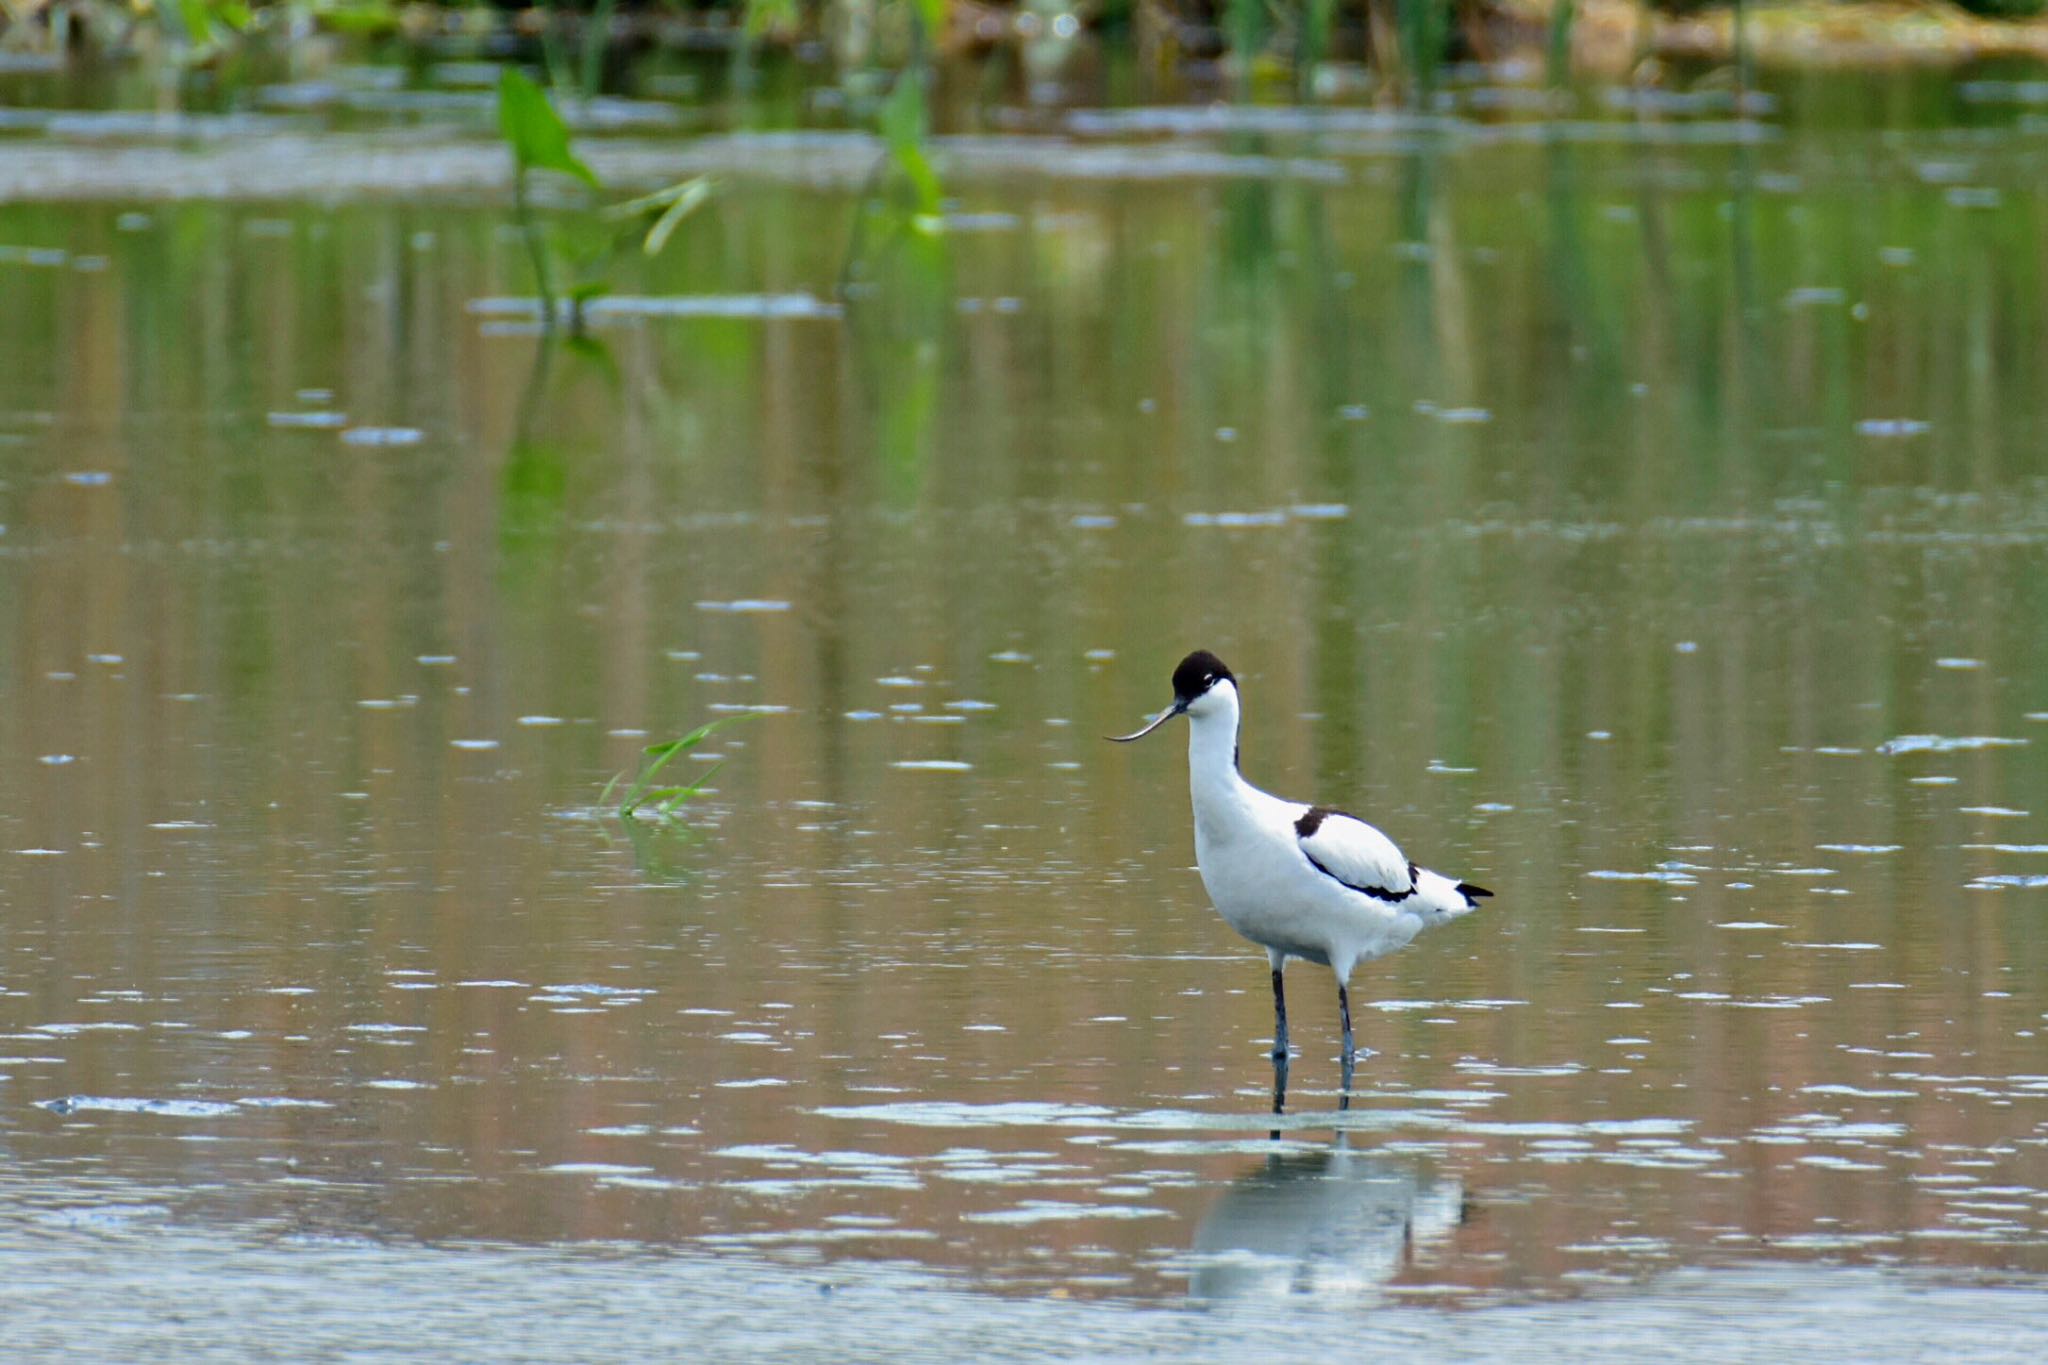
[1190,1134,1466,1300]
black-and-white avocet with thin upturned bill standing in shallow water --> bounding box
[1114,649,1493,1085]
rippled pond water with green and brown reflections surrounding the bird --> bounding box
[0,61,2048,1357]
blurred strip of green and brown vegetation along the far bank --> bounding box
[0,0,2048,100]
